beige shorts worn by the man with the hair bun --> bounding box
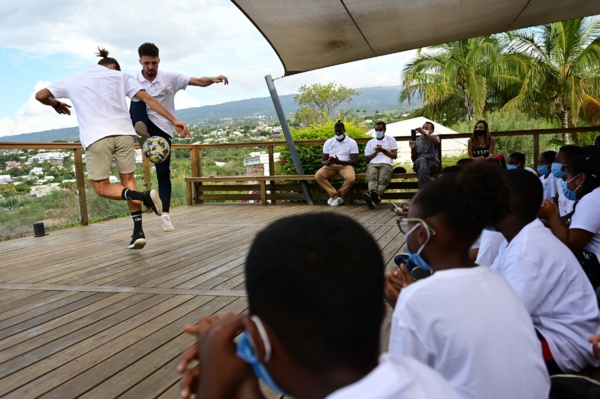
[85,136,135,180]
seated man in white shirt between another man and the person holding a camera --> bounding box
[363,121,398,209]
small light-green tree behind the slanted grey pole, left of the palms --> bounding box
[294,82,359,126]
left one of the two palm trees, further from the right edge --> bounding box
[399,34,527,121]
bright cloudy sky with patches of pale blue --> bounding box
[0,0,414,136]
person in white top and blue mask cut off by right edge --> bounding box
[539,155,600,288]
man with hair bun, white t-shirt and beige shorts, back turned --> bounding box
[35,49,189,249]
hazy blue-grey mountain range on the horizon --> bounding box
[0,86,421,143]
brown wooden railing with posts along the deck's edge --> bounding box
[0,126,600,225]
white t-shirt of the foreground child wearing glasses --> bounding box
[389,266,550,399]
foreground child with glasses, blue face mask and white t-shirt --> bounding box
[386,162,550,399]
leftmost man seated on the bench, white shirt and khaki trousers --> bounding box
[315,121,358,206]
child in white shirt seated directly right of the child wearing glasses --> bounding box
[492,170,600,375]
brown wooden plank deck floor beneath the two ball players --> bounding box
[0,205,403,399]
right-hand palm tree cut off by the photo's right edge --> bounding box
[503,18,600,144]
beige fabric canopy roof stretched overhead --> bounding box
[231,0,600,76]
